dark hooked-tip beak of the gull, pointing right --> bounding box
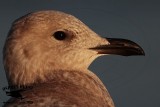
[90,38,145,56]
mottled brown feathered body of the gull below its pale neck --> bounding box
[3,70,114,107]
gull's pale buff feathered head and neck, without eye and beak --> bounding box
[4,11,108,85]
